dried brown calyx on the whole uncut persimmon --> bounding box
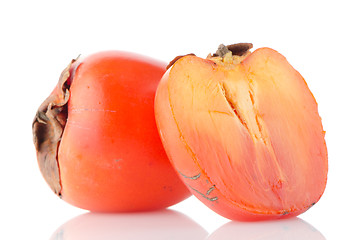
[33,59,76,197]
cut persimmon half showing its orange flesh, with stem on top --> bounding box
[155,44,328,220]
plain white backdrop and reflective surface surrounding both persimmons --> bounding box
[0,0,362,240]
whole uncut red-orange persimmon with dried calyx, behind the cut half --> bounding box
[33,51,191,212]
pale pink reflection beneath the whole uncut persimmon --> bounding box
[50,209,208,240]
